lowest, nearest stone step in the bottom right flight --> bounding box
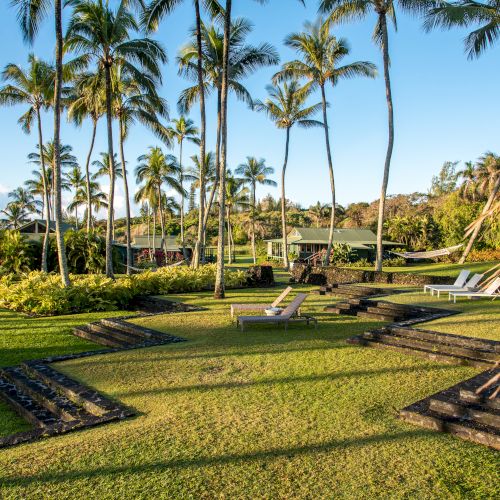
[399,400,500,450]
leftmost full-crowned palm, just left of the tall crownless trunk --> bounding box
[0,54,54,272]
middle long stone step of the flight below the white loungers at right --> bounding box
[362,330,496,363]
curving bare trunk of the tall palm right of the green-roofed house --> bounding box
[375,13,394,271]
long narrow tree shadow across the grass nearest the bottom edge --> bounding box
[0,429,436,487]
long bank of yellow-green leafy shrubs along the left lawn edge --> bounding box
[0,265,246,315]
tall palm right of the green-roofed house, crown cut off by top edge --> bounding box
[320,0,430,271]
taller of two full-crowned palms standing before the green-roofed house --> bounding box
[274,18,377,265]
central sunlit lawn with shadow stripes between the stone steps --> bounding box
[0,287,498,498]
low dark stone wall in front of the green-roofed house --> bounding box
[291,264,455,286]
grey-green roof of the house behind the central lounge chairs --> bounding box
[266,227,400,249]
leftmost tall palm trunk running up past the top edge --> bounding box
[53,0,71,287]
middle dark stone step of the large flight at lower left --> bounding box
[2,367,88,422]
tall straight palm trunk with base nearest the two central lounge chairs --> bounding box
[214,0,232,299]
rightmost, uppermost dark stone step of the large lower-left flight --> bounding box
[22,363,133,416]
